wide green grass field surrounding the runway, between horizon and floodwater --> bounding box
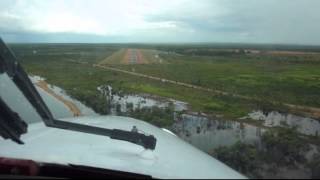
[9,45,320,121]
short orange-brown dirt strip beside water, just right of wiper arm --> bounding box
[35,81,81,117]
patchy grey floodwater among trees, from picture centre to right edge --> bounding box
[97,85,320,152]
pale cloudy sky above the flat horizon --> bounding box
[0,0,320,45]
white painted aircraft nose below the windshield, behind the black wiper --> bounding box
[0,116,245,179]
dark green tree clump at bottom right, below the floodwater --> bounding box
[211,128,317,178]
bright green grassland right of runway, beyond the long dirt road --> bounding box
[115,54,320,107]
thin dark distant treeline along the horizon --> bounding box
[9,43,320,52]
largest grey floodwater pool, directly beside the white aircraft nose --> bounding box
[172,114,265,152]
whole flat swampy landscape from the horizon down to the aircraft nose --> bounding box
[10,44,320,178]
